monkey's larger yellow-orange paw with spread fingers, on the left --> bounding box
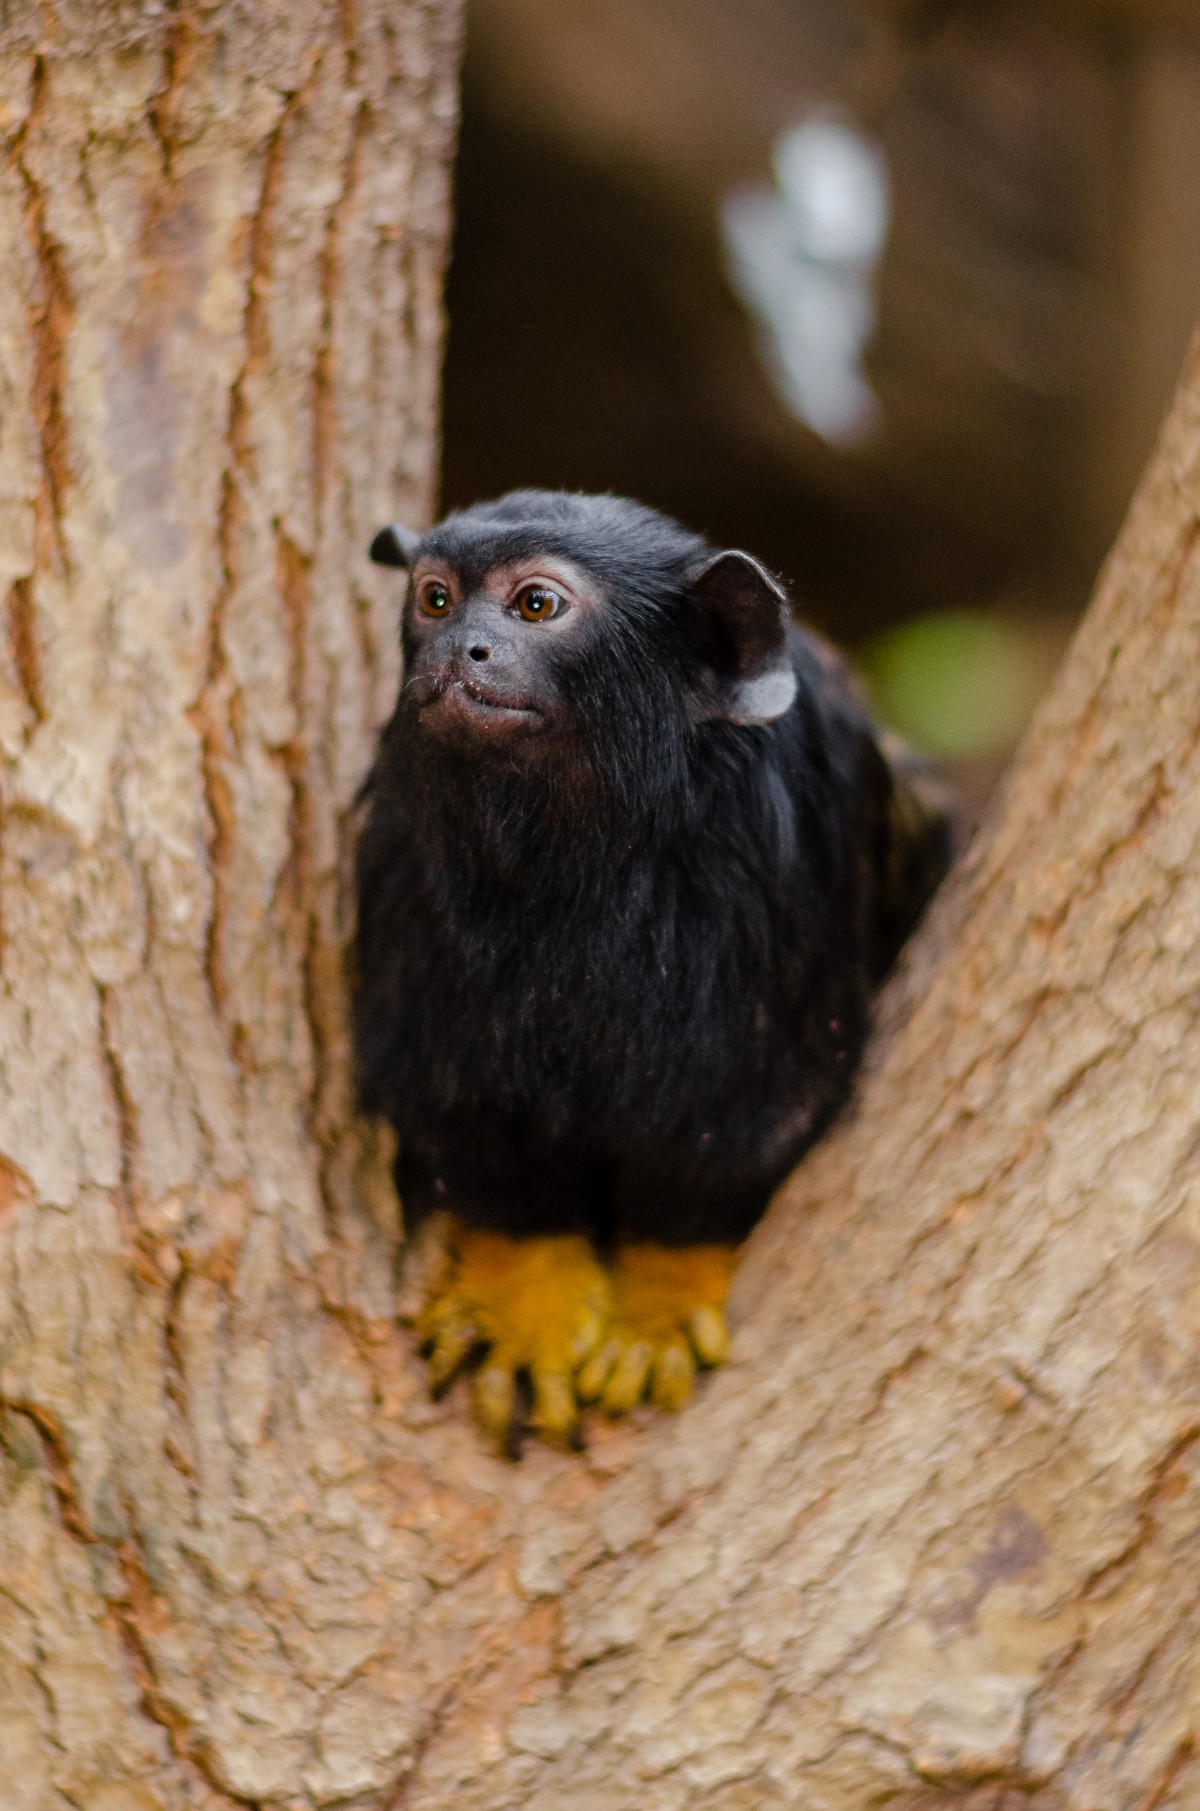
[418,1226,610,1452]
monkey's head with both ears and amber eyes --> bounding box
[371,491,796,791]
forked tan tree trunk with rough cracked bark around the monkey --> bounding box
[0,0,1200,1811]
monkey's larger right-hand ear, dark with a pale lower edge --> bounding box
[691,549,796,723]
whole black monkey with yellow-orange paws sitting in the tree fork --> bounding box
[355,491,948,1443]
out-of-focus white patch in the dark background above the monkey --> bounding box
[722,118,889,446]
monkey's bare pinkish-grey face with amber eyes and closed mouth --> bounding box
[405,552,603,748]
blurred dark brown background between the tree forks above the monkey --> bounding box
[443,0,1200,806]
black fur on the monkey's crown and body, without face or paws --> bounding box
[355,491,948,1244]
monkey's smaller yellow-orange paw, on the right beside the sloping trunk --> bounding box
[576,1244,737,1414]
